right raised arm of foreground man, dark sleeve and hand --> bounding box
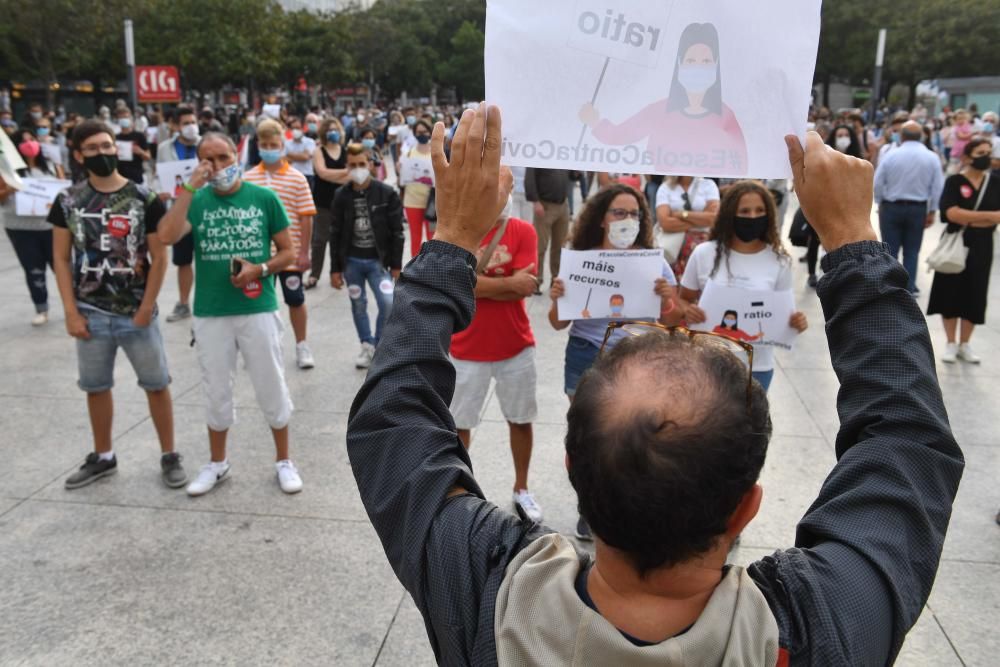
[750,133,964,665]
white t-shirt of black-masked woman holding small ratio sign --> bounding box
[681,241,792,371]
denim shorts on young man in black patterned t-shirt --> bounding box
[76,309,170,394]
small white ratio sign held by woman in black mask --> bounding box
[691,280,798,350]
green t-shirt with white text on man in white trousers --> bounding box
[188,181,289,317]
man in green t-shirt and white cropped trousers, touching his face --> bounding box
[159,132,302,496]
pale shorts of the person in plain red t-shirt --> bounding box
[451,347,538,431]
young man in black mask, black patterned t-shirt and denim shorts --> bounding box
[48,120,187,489]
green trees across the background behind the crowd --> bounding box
[0,0,1000,99]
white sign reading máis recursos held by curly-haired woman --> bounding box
[558,248,663,320]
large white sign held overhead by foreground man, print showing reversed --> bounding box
[485,0,821,178]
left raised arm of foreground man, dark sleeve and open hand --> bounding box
[347,106,544,664]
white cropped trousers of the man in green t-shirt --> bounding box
[193,312,292,431]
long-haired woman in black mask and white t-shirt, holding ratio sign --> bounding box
[680,181,809,391]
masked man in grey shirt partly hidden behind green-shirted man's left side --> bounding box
[156,107,201,322]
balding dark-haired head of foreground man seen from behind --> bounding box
[566,333,771,575]
